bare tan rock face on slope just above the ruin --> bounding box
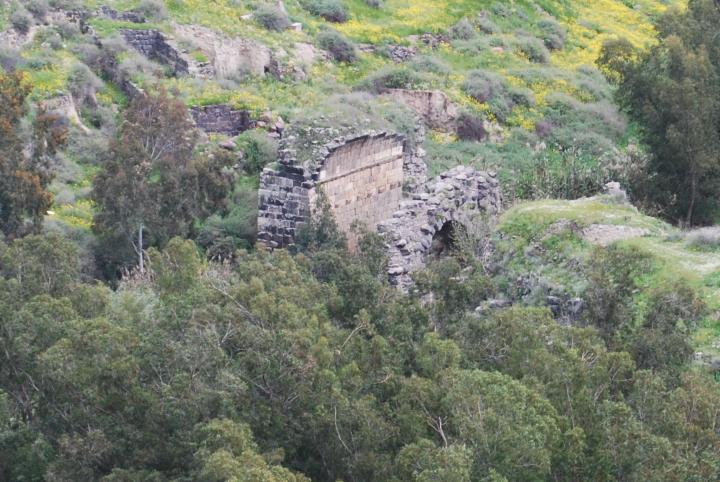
[385,89,458,131]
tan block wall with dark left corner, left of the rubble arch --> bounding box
[258,133,405,248]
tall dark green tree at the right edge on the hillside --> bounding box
[598,0,720,226]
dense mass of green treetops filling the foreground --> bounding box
[0,229,720,481]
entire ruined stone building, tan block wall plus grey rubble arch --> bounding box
[258,126,502,290]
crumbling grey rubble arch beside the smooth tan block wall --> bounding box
[377,166,502,290]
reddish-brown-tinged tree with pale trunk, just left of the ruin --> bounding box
[92,89,235,278]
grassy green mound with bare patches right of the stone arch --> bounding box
[499,196,720,359]
